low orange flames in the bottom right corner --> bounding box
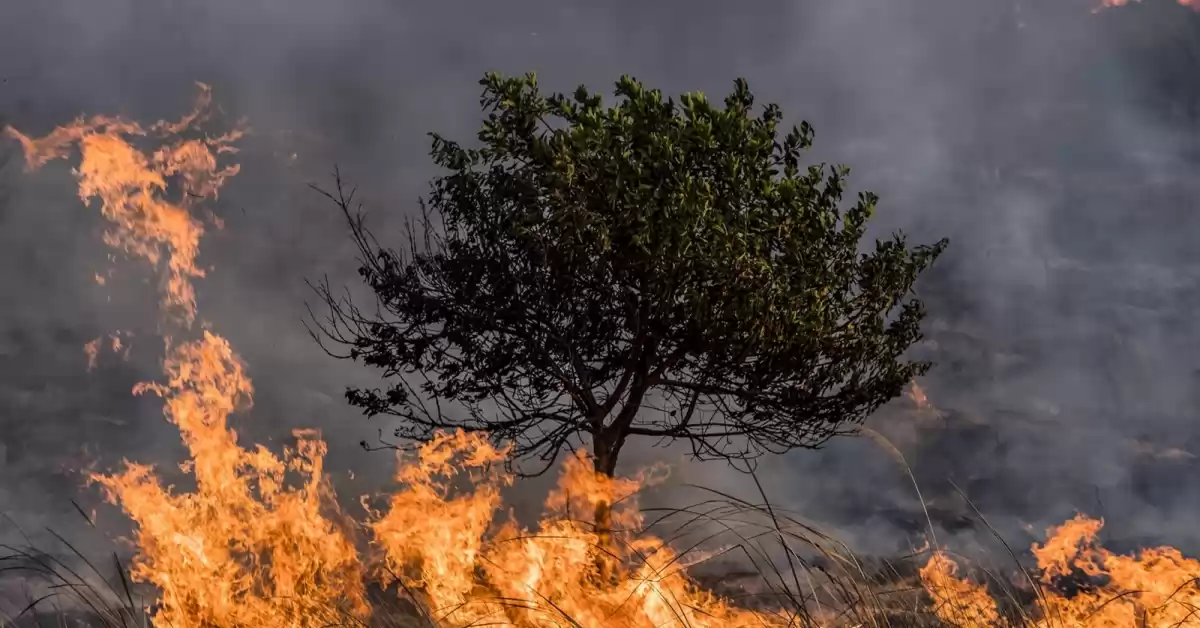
[920,515,1200,628]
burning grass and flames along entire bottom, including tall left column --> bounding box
[7,88,1200,628]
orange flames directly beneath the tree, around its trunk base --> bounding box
[371,432,775,628]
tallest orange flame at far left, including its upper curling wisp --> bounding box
[7,84,366,628]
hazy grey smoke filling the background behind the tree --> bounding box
[0,0,1200,564]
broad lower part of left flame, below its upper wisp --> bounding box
[92,331,366,627]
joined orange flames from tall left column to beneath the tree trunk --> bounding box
[16,85,786,628]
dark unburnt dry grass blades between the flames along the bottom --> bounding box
[0,486,1060,628]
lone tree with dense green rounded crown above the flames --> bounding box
[313,73,947,487]
